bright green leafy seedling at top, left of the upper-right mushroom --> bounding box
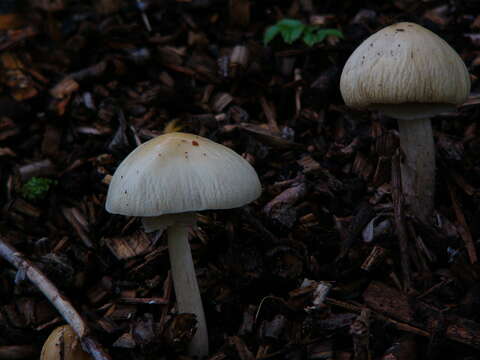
[263,19,343,46]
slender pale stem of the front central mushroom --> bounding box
[167,224,208,358]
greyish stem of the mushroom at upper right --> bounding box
[398,118,435,223]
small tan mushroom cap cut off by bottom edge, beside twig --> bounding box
[40,325,92,360]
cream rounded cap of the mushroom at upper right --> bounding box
[340,22,470,119]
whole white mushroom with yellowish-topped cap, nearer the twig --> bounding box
[106,133,261,357]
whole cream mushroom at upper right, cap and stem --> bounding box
[340,22,470,222]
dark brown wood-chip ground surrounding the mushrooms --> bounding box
[0,0,480,360]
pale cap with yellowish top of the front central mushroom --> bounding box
[106,133,262,216]
